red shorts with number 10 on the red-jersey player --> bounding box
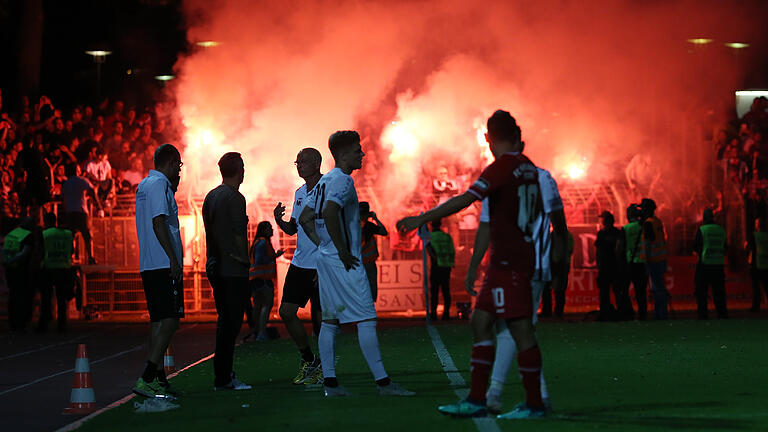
[475,266,533,319]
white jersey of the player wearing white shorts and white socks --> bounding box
[307,168,362,259]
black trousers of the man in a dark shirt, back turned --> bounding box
[208,274,250,386]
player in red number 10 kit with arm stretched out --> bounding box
[397,110,546,418]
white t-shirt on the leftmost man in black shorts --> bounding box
[136,170,183,271]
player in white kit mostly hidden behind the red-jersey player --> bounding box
[465,168,567,418]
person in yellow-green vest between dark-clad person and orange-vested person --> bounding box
[622,204,648,321]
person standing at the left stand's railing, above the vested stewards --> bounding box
[61,165,103,264]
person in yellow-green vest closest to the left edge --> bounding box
[2,218,35,332]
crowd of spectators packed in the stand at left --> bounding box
[0,91,172,232]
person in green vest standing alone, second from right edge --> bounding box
[694,209,728,319]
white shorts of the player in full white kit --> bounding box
[317,253,376,324]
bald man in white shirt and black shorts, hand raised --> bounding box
[274,148,323,384]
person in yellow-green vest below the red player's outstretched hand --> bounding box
[427,219,456,321]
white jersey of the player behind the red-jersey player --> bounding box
[480,167,563,282]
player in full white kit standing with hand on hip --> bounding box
[299,131,413,396]
